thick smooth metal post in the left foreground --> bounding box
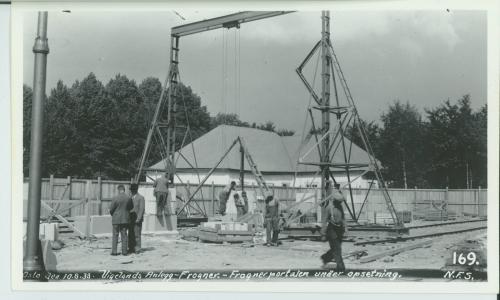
[24,11,49,271]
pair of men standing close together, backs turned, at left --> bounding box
[109,183,145,255]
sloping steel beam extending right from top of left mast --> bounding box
[171,11,293,37]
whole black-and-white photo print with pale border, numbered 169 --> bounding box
[12,2,499,292]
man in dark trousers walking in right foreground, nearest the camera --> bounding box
[321,184,346,272]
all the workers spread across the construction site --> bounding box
[109,174,347,271]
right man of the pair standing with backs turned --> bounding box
[128,183,146,254]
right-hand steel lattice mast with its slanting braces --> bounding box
[296,11,402,226]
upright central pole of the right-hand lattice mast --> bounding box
[320,11,332,199]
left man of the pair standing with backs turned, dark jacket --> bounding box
[109,184,134,255]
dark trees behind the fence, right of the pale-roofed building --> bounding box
[346,95,487,188]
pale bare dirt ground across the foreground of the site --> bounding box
[54,221,486,271]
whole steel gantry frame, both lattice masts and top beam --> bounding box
[135,11,402,226]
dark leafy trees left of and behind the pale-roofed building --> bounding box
[23,73,294,180]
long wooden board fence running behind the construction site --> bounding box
[23,177,487,219]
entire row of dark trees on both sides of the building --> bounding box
[23,73,487,188]
